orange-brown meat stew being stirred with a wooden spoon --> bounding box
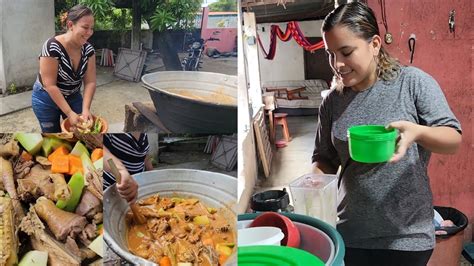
[127,194,236,266]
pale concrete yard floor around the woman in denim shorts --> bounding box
[0,56,237,132]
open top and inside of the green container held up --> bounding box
[347,125,397,141]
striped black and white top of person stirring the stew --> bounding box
[104,133,150,190]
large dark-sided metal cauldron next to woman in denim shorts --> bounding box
[142,71,237,134]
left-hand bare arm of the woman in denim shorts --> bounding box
[40,57,79,125]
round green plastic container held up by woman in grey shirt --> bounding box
[347,125,397,163]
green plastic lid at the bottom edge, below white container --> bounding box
[237,246,324,266]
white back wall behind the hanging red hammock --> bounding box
[257,20,322,83]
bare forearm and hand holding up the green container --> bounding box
[388,121,462,162]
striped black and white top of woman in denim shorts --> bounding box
[38,37,95,96]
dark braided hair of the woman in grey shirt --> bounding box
[321,2,400,89]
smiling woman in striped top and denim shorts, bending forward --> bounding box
[32,5,96,132]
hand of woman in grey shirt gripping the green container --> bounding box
[387,121,421,163]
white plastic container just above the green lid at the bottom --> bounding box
[237,226,285,247]
